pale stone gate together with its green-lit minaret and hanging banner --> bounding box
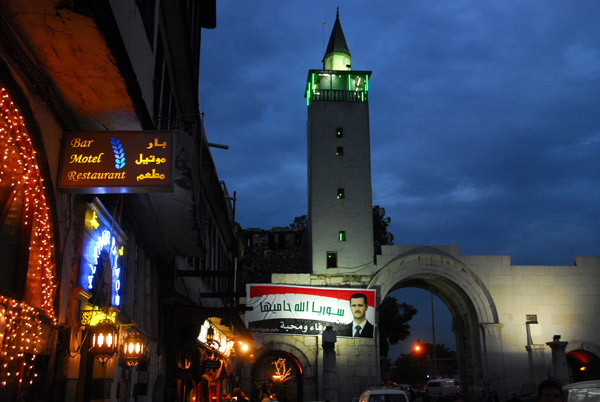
[243,10,600,402]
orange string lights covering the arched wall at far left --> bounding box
[0,88,56,387]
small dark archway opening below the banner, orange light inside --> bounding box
[252,350,303,402]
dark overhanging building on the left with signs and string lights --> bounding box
[0,0,251,402]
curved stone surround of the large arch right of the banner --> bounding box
[369,247,504,401]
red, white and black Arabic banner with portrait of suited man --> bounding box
[245,284,376,338]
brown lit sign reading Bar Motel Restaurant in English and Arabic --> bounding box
[58,131,174,194]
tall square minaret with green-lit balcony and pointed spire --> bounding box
[305,9,374,275]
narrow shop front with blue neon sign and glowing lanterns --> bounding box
[79,198,135,399]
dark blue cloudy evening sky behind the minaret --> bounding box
[200,0,600,352]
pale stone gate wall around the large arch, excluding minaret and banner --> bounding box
[256,246,600,401]
